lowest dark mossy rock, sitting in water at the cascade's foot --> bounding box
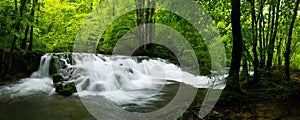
[54,82,77,96]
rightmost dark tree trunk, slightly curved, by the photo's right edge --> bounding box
[284,0,300,81]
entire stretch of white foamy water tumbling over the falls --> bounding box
[0,53,226,104]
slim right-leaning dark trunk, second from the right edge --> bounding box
[267,0,280,68]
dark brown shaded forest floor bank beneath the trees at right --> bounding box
[205,70,300,120]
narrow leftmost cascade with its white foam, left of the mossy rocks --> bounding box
[0,54,55,101]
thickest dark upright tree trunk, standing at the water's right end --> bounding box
[228,0,243,92]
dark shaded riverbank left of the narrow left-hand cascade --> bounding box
[0,49,44,85]
